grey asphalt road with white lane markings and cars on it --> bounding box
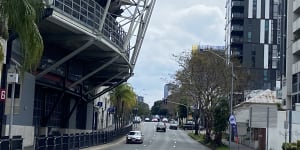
[105,122,209,150]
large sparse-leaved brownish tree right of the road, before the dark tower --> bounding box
[175,49,231,142]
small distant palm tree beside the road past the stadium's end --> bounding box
[110,83,136,128]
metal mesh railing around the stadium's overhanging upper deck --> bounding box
[51,0,126,53]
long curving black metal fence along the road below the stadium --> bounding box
[35,125,132,150]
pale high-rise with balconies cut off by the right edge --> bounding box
[282,0,300,110]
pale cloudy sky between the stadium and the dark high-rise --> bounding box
[128,0,226,108]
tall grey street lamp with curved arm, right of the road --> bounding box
[202,50,235,149]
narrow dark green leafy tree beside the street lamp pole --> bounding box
[213,98,229,145]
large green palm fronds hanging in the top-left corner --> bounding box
[0,0,44,74]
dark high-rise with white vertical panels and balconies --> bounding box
[225,0,284,90]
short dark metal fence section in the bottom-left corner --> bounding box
[0,136,23,150]
